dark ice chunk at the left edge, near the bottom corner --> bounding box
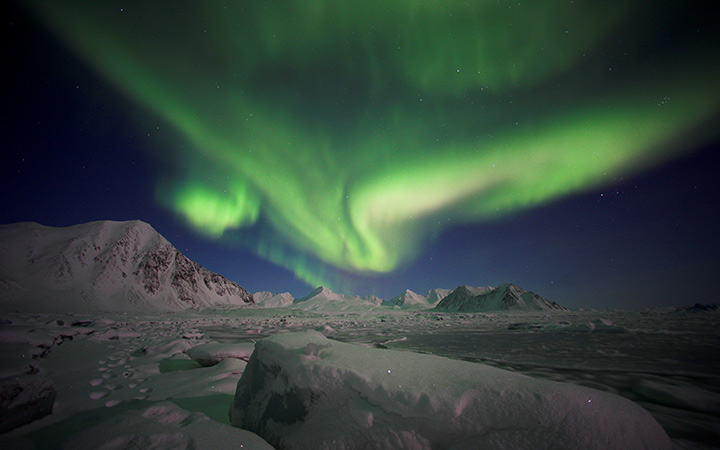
[0,375,56,433]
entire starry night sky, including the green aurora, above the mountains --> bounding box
[0,0,720,308]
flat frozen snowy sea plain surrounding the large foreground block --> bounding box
[0,309,720,449]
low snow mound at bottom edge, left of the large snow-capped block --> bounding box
[60,402,272,450]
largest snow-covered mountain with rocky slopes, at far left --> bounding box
[0,220,253,311]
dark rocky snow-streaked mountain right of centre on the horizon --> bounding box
[435,284,567,312]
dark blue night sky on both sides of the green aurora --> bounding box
[5,0,720,308]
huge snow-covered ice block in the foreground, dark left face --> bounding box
[230,331,671,450]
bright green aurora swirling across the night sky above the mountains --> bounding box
[30,0,720,286]
